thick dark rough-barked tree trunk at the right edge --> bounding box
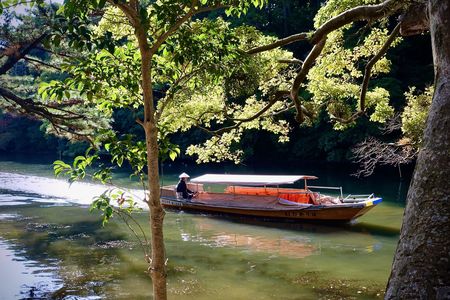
[386,0,450,299]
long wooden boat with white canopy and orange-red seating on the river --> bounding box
[161,174,382,222]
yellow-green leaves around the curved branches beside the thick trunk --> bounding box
[307,0,401,129]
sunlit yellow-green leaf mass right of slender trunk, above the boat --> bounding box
[156,19,294,162]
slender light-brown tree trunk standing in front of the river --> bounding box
[136,29,167,300]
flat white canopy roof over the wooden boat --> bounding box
[191,174,317,186]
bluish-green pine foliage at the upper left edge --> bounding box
[0,1,109,144]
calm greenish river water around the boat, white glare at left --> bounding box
[0,156,406,299]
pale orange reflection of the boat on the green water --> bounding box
[172,213,384,258]
